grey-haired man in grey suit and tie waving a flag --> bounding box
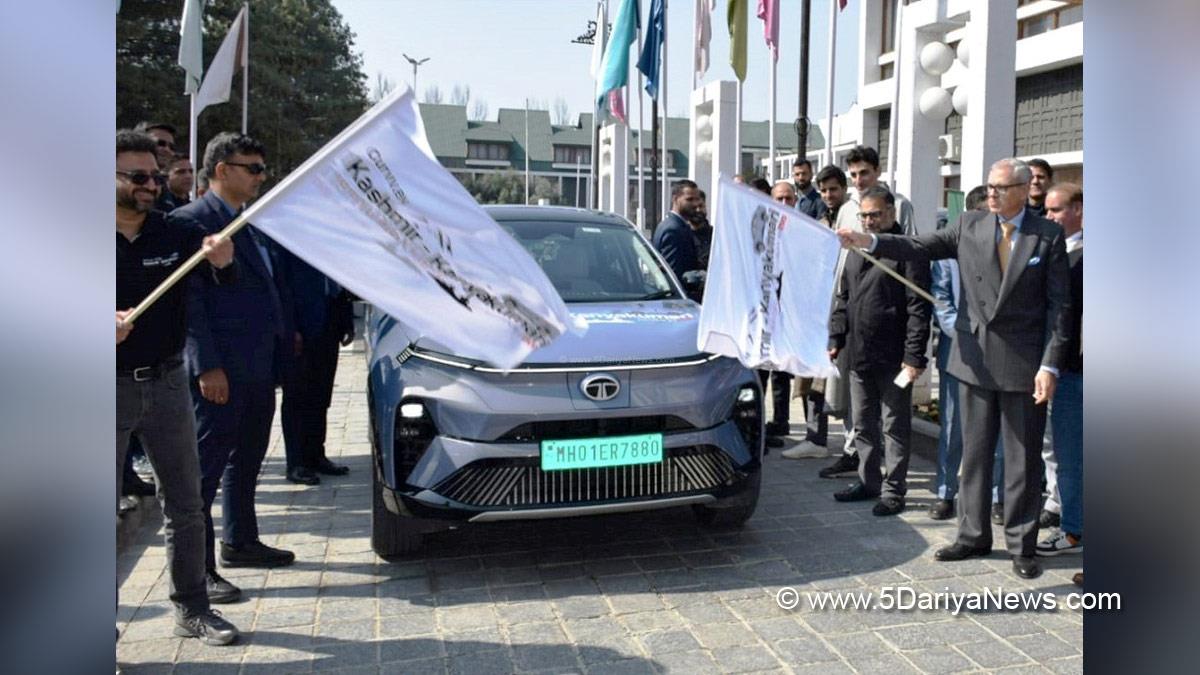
[838,159,1073,579]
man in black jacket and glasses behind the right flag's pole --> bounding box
[829,185,931,515]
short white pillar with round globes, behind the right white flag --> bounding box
[688,80,738,199]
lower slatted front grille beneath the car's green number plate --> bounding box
[433,446,733,507]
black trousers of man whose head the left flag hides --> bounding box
[280,314,338,470]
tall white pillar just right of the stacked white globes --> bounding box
[959,0,1016,191]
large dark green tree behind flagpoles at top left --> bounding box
[116,0,368,180]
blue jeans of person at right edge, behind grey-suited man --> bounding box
[1050,372,1084,536]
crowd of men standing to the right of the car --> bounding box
[653,145,1084,585]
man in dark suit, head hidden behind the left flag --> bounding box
[280,249,354,485]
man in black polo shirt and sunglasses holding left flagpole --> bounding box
[116,130,238,645]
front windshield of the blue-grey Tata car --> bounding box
[500,221,678,303]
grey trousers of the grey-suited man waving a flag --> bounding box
[958,382,1046,556]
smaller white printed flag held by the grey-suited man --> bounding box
[696,175,840,377]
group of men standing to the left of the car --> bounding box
[116,123,354,645]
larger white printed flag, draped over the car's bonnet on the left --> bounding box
[244,85,571,369]
